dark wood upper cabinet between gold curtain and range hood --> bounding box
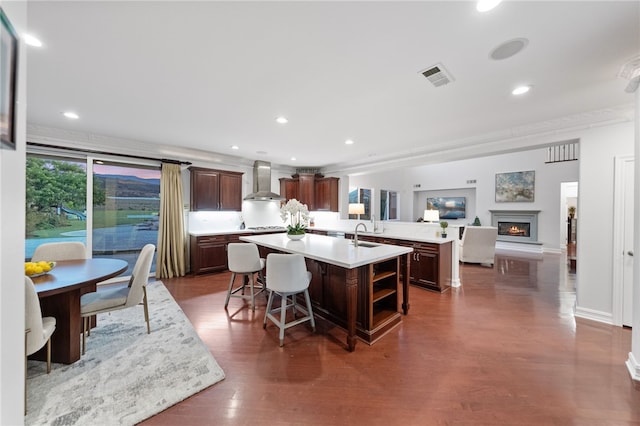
[189,167,242,211]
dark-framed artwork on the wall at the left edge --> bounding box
[0,8,18,149]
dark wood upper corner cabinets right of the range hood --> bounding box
[280,173,340,212]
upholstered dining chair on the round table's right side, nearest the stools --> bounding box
[80,244,156,355]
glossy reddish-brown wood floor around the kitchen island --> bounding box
[143,254,640,426]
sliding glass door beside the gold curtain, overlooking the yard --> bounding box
[25,154,160,274]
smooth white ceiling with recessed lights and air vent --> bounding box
[22,1,640,168]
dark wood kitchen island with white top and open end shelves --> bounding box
[240,233,413,351]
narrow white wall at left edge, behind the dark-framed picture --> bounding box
[0,1,27,425]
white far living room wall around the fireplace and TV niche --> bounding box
[349,149,579,251]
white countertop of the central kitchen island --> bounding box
[240,233,413,269]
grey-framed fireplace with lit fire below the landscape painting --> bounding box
[491,210,539,243]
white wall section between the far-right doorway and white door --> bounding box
[576,123,634,323]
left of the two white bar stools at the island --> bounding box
[224,243,265,311]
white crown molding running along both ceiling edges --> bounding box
[27,103,635,175]
